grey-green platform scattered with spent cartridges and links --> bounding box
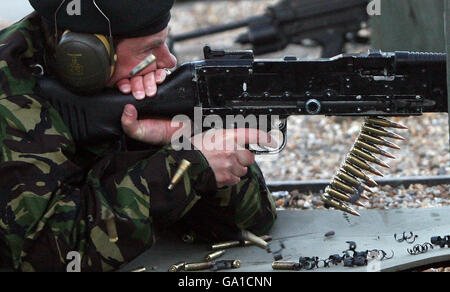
[121,207,450,272]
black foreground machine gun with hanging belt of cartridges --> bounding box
[38,47,448,215]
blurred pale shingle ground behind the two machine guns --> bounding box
[0,0,450,209]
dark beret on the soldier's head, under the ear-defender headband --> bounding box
[29,0,175,38]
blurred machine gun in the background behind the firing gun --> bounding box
[169,0,368,58]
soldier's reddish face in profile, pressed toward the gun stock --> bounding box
[107,28,177,87]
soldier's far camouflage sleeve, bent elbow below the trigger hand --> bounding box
[173,163,277,242]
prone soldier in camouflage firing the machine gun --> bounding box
[0,0,276,271]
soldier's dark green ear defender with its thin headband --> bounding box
[55,0,117,94]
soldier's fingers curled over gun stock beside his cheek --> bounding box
[117,69,168,100]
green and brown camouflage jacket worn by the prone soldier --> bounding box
[0,15,276,271]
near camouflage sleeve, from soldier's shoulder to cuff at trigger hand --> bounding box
[0,95,215,271]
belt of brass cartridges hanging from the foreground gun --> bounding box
[322,117,407,217]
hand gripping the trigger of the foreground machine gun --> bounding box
[191,129,277,188]
